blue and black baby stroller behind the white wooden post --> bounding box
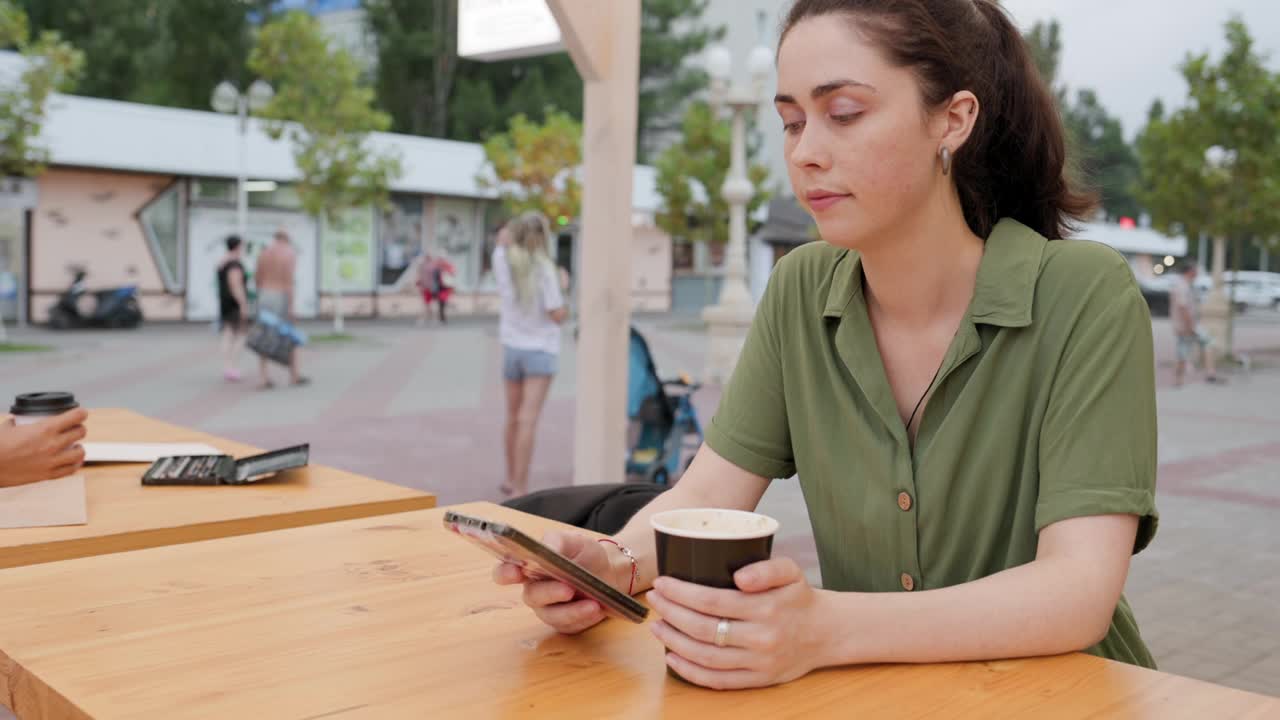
[627,328,703,486]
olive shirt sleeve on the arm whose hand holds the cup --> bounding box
[1036,282,1158,553]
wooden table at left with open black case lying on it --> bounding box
[0,410,435,566]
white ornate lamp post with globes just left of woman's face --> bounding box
[703,45,773,382]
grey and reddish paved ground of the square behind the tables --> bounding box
[0,314,1280,696]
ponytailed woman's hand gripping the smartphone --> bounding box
[493,532,626,635]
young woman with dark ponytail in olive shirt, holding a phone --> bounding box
[495,0,1156,688]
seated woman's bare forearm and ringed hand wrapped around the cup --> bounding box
[649,515,1138,689]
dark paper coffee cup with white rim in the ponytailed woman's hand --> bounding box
[649,507,778,588]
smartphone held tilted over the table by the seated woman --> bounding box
[444,510,649,623]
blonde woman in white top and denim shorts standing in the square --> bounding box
[493,213,568,496]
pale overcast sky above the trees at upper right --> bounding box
[1004,0,1280,138]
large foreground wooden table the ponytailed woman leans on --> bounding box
[0,503,1280,720]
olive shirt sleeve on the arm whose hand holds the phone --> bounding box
[707,269,796,479]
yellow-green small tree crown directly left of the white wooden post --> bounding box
[476,110,582,222]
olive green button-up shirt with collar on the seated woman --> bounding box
[707,219,1157,667]
